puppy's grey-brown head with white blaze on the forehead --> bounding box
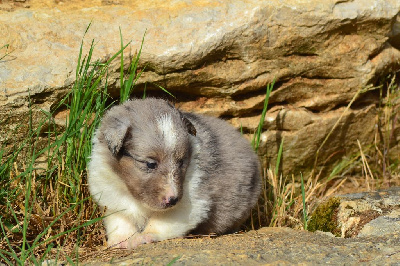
[97,99,196,210]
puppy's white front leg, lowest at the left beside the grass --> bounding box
[104,212,139,248]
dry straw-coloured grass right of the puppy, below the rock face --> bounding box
[250,75,400,233]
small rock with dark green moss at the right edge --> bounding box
[309,187,400,237]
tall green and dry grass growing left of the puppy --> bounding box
[0,25,144,265]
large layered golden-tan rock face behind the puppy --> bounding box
[0,0,400,174]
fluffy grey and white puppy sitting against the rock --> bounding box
[88,98,261,248]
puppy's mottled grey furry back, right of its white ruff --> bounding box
[184,113,261,234]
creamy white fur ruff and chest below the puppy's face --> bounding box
[89,134,210,245]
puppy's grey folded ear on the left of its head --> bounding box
[103,117,129,156]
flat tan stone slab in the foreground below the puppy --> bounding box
[81,228,400,265]
